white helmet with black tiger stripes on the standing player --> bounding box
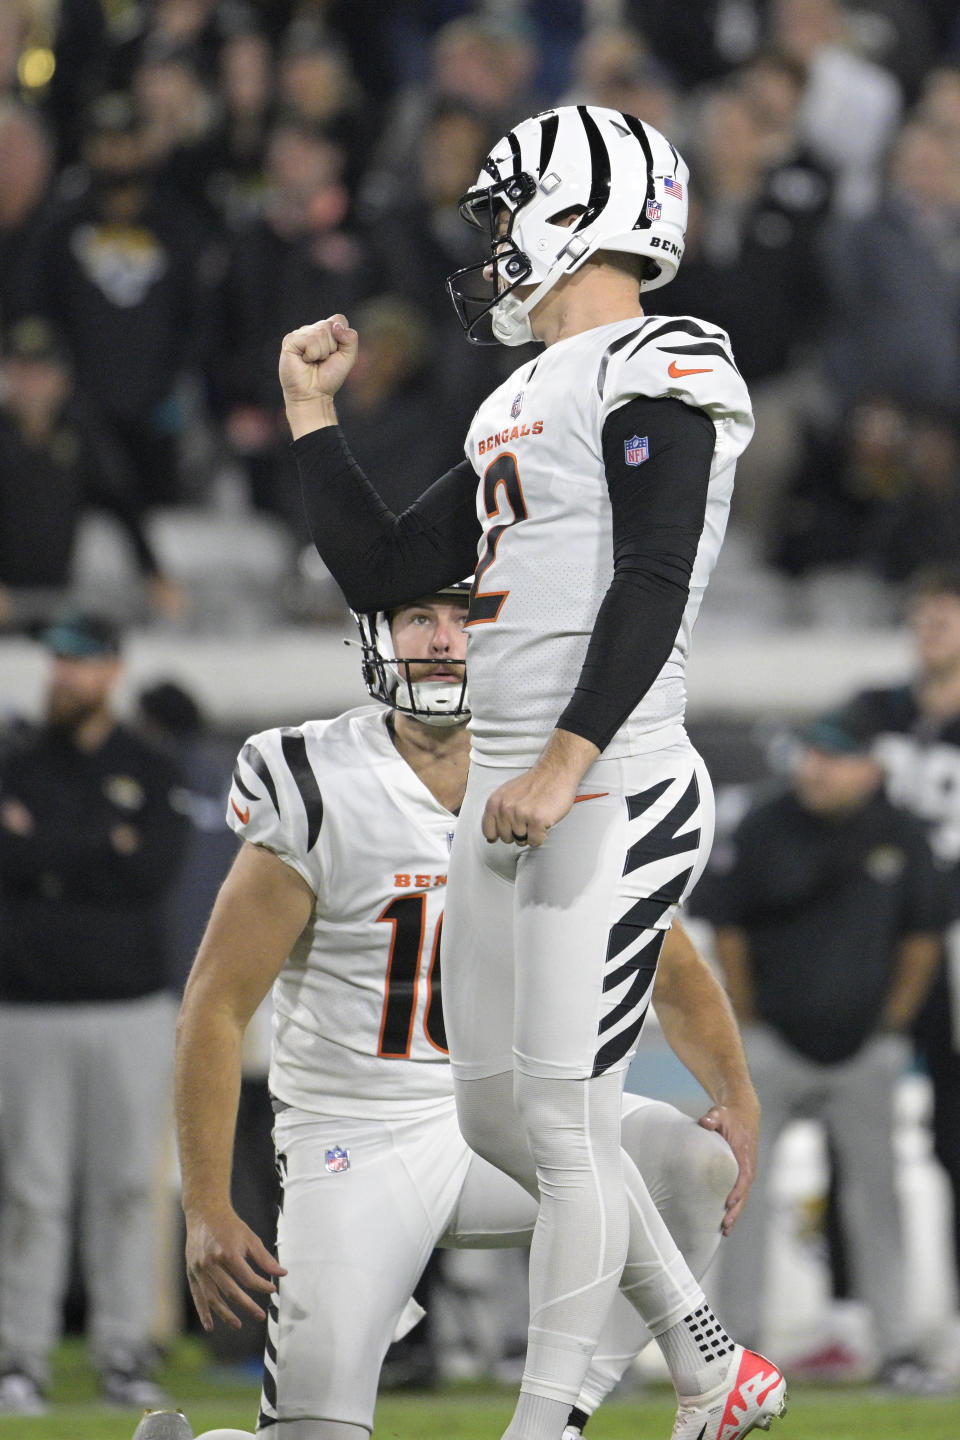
[446,105,689,346]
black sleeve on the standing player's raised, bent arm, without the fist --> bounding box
[294,425,481,611]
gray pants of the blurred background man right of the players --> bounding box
[712,1025,911,1359]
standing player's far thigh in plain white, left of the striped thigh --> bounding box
[440,765,518,1080]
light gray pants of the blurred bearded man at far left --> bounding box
[0,995,176,1381]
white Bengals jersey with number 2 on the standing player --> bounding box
[465,315,753,765]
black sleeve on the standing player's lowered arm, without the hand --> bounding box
[557,397,717,750]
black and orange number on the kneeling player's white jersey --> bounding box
[377,894,446,1060]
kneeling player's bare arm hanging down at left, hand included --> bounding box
[176,844,314,1331]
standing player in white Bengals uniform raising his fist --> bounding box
[279,105,786,1440]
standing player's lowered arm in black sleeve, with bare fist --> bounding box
[484,397,717,845]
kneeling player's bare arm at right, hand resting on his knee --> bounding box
[653,920,760,1234]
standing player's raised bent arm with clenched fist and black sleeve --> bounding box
[279,315,481,611]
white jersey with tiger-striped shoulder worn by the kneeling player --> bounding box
[227,706,456,1117]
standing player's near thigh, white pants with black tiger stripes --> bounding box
[514,742,714,1079]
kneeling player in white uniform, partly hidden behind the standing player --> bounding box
[170,586,759,1440]
